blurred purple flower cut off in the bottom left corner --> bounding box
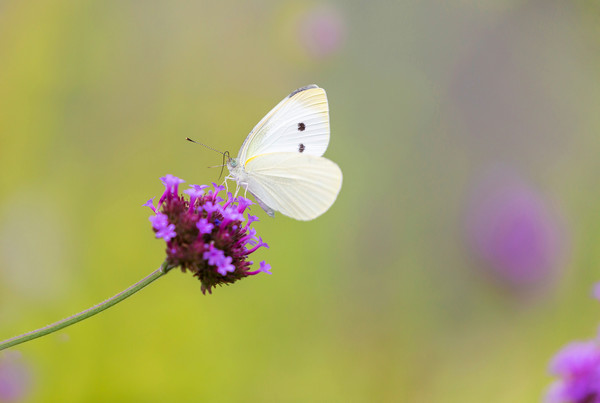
[0,351,31,402]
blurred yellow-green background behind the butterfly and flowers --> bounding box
[0,0,600,402]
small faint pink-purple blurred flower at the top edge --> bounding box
[299,5,346,59]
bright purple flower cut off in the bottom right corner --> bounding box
[545,340,600,403]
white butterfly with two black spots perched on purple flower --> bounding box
[226,84,342,220]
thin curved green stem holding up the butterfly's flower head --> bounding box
[0,262,170,350]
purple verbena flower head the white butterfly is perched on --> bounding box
[144,175,271,293]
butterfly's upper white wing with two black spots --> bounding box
[238,84,329,164]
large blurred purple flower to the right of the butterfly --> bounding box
[467,173,563,286]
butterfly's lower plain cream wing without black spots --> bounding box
[246,153,342,221]
